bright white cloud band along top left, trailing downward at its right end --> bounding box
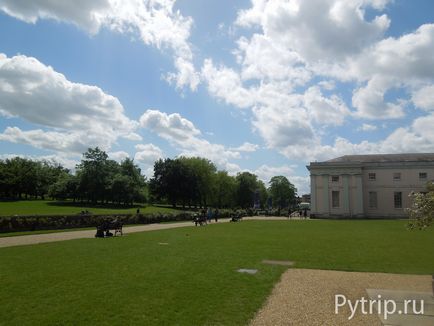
[0,0,199,90]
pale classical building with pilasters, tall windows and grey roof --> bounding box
[307,153,434,218]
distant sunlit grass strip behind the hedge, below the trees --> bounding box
[0,200,183,216]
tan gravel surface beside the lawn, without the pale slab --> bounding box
[250,268,432,326]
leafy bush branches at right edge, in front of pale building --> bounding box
[407,181,434,229]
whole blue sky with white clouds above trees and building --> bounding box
[0,0,434,195]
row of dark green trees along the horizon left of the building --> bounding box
[0,147,297,209]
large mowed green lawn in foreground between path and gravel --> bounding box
[0,221,434,325]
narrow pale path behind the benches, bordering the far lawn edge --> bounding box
[0,216,287,248]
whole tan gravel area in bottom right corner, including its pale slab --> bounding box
[250,268,434,326]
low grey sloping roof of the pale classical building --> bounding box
[323,153,434,163]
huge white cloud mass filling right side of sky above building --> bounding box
[202,0,434,166]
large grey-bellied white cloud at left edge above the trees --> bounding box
[0,54,140,152]
